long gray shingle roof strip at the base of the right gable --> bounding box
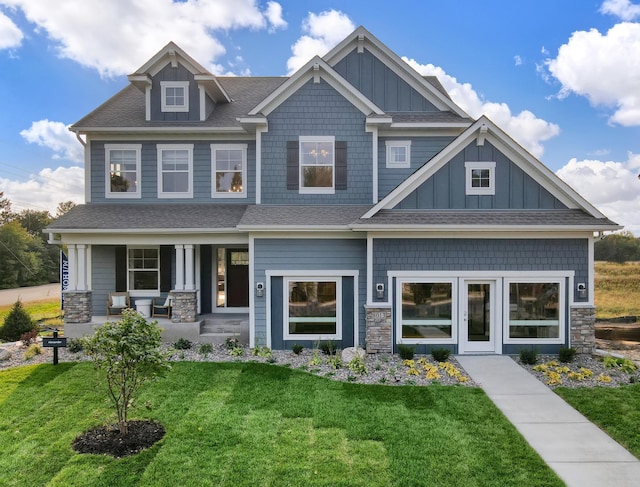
[355,209,618,230]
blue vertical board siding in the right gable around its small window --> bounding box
[397,141,566,209]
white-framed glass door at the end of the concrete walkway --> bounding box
[459,279,500,353]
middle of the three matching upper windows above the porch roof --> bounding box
[157,144,193,198]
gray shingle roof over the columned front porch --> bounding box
[48,203,247,233]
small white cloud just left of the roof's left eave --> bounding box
[20,119,84,162]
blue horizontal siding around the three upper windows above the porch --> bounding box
[91,140,256,204]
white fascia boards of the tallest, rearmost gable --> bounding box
[323,26,469,118]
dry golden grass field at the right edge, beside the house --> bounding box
[595,262,640,319]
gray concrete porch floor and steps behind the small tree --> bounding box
[64,314,249,345]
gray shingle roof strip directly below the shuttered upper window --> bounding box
[239,205,371,229]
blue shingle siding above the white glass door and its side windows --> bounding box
[373,238,589,302]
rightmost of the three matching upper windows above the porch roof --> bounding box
[211,144,247,198]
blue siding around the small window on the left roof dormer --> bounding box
[151,63,200,122]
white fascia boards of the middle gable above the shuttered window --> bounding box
[248,56,384,115]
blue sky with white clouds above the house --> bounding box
[0,0,640,236]
